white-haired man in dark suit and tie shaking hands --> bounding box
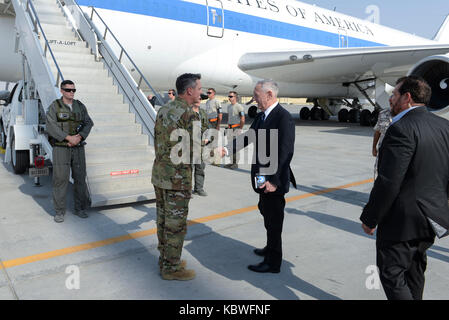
[220,80,296,273]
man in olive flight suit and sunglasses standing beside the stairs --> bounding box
[47,80,94,223]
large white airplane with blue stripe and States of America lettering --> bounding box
[0,0,449,123]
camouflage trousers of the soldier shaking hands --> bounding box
[154,186,192,272]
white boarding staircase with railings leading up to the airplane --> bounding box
[12,0,161,207]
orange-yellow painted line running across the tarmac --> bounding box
[0,179,374,270]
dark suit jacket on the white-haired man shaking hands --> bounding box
[232,104,296,194]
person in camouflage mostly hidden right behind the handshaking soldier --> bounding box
[192,102,209,197]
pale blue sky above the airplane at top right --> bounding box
[300,0,449,38]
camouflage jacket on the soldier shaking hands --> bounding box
[151,97,199,190]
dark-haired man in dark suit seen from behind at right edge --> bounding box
[360,77,449,300]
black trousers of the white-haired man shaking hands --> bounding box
[258,193,285,268]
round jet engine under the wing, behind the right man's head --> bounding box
[409,53,449,110]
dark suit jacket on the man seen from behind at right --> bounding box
[360,107,449,241]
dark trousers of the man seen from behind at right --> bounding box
[376,237,435,300]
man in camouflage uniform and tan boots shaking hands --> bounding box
[151,74,201,280]
